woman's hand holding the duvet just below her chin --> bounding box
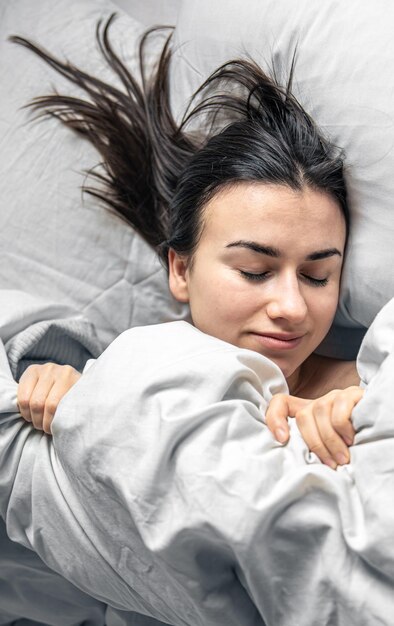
[265,386,364,469]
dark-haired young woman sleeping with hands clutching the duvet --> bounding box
[14,18,362,468]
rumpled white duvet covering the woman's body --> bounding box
[0,290,394,626]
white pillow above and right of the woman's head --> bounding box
[171,0,394,352]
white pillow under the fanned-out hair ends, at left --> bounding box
[0,0,186,346]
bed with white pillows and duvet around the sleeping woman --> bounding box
[0,0,394,626]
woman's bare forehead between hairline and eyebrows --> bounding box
[200,183,346,253]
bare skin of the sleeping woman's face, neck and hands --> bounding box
[18,183,363,468]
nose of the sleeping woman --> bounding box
[266,276,308,324]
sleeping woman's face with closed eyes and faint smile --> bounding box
[169,183,346,379]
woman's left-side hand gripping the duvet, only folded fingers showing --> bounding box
[17,363,81,435]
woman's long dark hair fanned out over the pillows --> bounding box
[11,15,349,264]
